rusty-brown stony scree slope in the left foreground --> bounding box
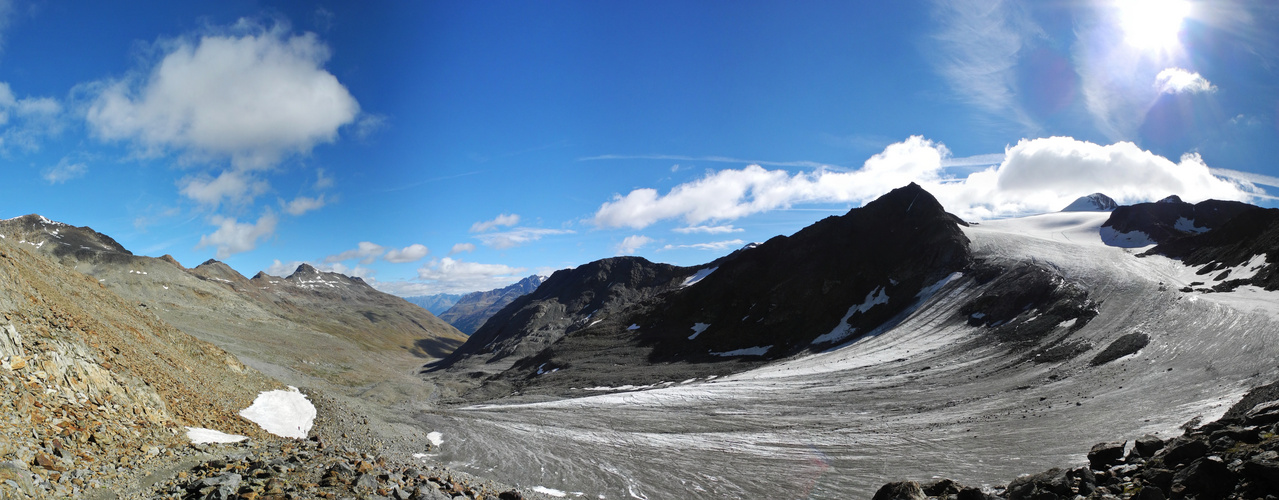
[0,214,279,497]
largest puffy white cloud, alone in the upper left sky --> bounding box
[86,20,359,169]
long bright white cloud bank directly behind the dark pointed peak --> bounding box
[592,136,1260,229]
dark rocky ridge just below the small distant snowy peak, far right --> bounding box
[1101,196,1256,247]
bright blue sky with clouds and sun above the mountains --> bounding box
[0,0,1279,295]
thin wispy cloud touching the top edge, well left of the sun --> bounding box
[932,0,1045,129]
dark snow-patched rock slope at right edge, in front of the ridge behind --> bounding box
[1145,206,1279,292]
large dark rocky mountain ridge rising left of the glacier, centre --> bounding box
[428,184,973,398]
